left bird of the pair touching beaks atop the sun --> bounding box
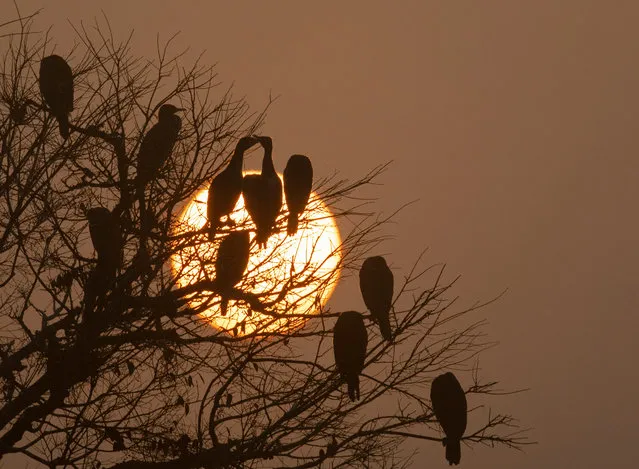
[206,137,257,241]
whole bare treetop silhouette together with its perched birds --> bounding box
[0,8,528,469]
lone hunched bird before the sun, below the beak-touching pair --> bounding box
[215,231,250,316]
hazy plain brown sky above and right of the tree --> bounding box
[8,0,639,469]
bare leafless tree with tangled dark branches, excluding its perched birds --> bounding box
[0,11,528,468]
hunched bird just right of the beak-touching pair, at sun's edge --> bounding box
[284,155,313,236]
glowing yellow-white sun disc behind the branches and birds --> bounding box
[172,171,341,335]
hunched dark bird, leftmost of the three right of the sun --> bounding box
[333,311,368,401]
